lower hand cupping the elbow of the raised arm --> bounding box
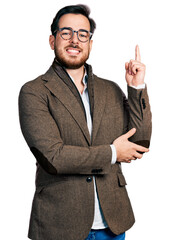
[113,128,149,163]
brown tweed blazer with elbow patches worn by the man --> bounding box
[19,61,151,240]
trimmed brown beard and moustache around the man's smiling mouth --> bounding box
[54,44,90,69]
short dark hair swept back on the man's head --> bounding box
[51,4,96,36]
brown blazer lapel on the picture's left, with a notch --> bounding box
[42,67,91,145]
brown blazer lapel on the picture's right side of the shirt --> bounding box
[92,75,106,144]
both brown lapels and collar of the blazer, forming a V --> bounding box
[42,61,106,145]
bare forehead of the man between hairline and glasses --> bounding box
[59,13,90,31]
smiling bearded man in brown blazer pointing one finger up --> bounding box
[19,5,151,240]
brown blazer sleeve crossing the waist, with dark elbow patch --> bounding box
[19,84,112,174]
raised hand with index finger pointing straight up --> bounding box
[125,45,146,87]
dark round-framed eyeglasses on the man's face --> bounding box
[54,27,93,43]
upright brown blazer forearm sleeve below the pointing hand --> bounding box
[128,87,152,147]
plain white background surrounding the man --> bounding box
[0,0,170,240]
